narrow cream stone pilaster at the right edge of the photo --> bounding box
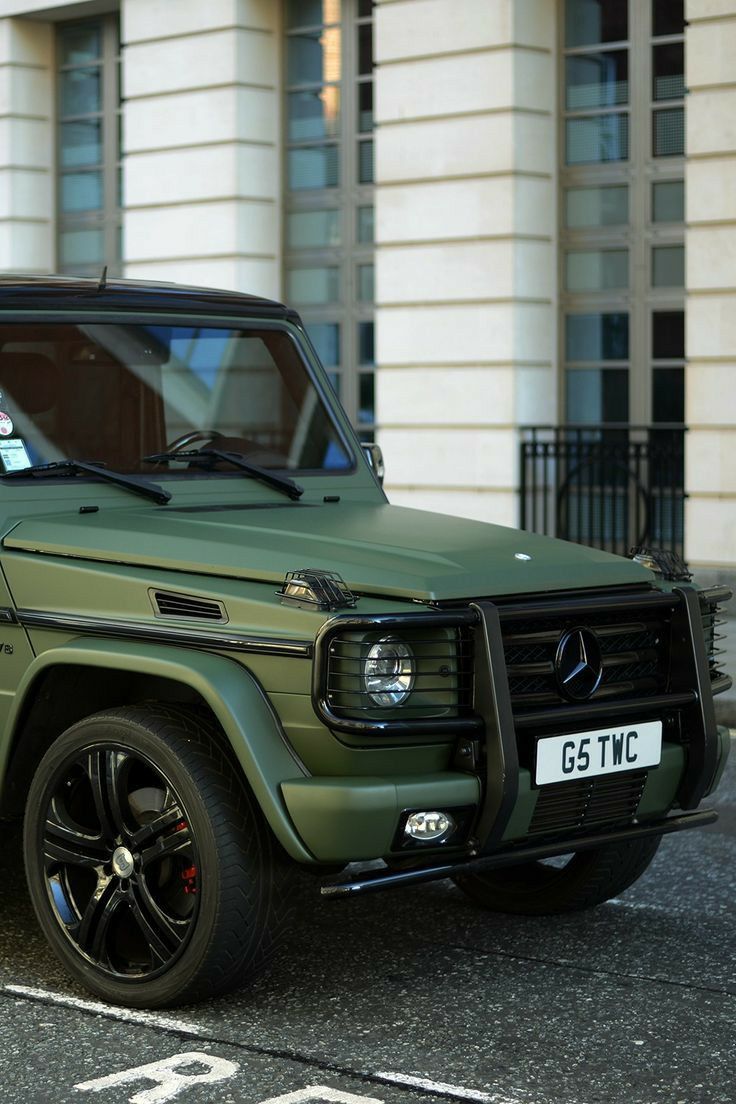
[685,0,736,571]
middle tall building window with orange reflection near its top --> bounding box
[284,0,375,440]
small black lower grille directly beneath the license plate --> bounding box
[529,771,647,836]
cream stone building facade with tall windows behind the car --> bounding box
[0,0,736,573]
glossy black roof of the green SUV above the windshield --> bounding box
[0,275,298,320]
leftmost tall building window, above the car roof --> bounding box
[56,15,121,275]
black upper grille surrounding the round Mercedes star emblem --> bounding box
[502,608,670,714]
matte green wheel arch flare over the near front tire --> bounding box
[0,640,314,862]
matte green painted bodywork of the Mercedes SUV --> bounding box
[0,302,728,862]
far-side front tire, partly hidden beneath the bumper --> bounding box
[454,836,662,916]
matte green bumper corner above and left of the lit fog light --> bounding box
[281,772,480,862]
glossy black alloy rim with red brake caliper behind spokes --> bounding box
[37,744,201,978]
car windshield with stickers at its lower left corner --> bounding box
[0,322,352,476]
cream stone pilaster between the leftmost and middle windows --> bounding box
[121,0,281,296]
